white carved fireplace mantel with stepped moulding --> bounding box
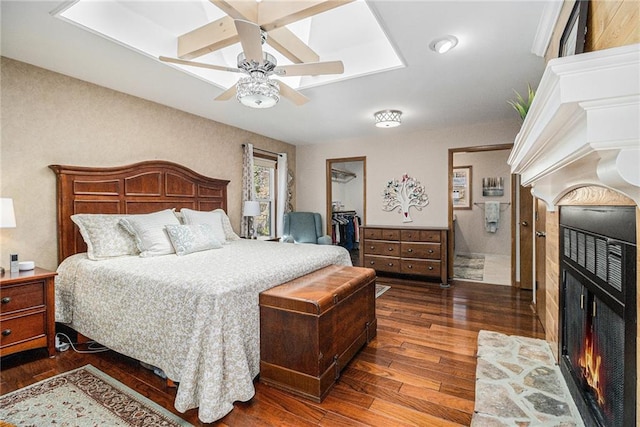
[508,44,640,211]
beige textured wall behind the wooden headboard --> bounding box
[0,58,295,269]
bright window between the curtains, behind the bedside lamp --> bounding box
[253,156,277,238]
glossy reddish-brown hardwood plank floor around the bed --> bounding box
[0,277,543,427]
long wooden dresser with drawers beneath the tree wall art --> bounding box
[360,225,448,285]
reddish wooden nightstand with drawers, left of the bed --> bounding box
[0,267,57,357]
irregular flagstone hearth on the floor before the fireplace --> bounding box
[471,331,583,427]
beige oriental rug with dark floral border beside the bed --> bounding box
[0,365,192,427]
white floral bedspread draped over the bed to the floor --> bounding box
[56,240,351,422]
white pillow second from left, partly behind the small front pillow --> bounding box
[120,209,180,257]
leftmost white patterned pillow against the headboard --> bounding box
[71,214,140,261]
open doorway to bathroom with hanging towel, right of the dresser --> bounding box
[448,144,516,286]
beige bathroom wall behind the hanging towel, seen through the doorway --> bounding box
[453,150,511,255]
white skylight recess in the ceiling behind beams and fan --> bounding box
[52,0,404,89]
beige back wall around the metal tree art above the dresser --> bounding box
[296,120,521,231]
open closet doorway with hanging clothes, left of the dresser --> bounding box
[325,157,367,263]
